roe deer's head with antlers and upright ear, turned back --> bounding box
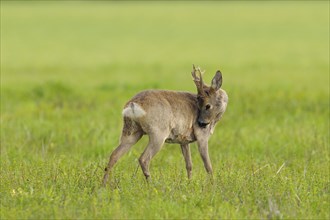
[191,65,226,128]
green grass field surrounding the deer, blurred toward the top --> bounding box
[0,1,330,219]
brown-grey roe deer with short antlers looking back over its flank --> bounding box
[103,66,228,185]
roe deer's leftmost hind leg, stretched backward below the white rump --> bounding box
[103,117,143,186]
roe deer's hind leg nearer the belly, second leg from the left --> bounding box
[139,134,166,180]
